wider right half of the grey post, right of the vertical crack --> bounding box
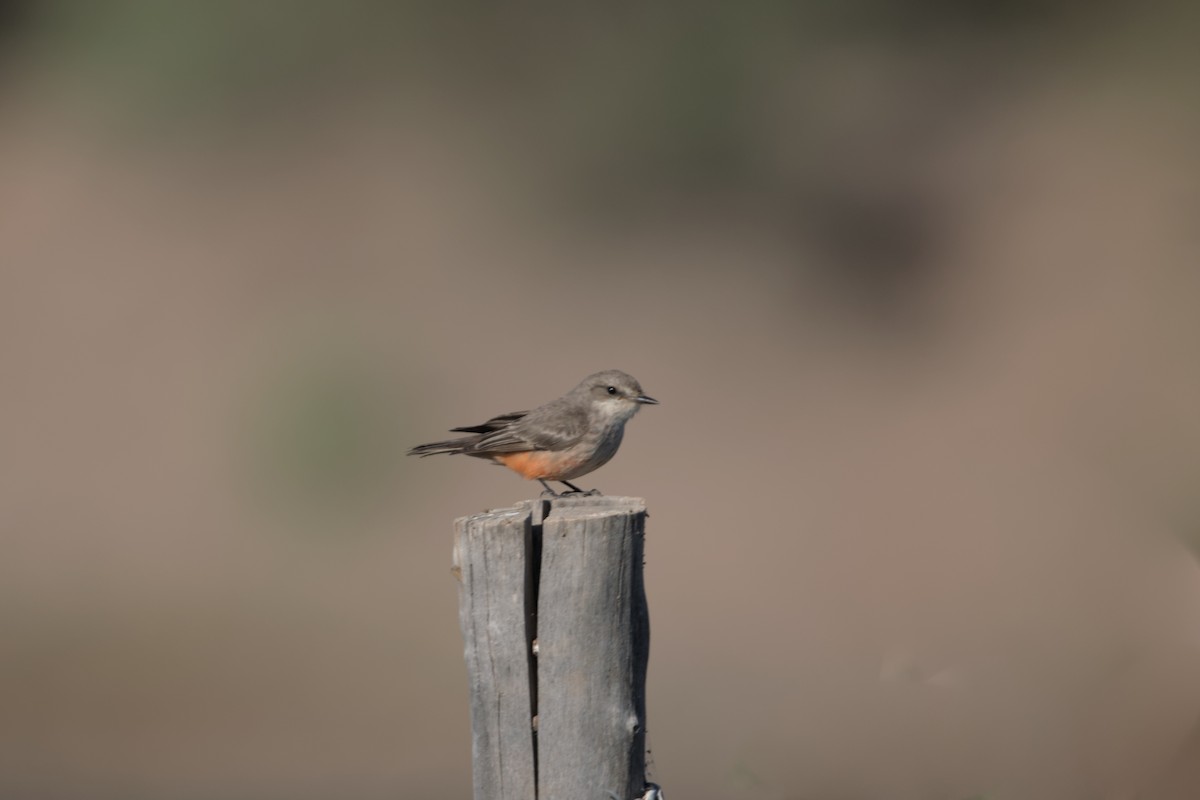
[538,498,649,800]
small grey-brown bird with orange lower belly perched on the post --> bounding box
[408,369,658,497]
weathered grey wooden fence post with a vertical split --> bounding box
[455,497,650,800]
